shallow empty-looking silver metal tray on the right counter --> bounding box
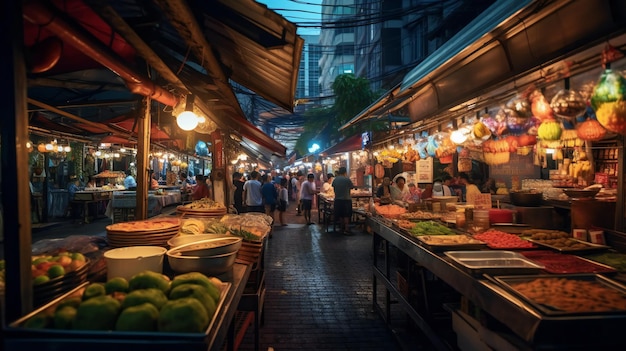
[444,250,544,275]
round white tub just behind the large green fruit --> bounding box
[104,246,167,280]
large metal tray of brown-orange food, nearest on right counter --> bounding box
[488,274,626,316]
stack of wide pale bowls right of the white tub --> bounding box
[166,236,242,275]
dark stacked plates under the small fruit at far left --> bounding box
[33,261,89,306]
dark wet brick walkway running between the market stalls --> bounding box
[239,206,399,351]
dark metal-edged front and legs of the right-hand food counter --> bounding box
[367,217,626,349]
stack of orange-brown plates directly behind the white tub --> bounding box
[106,218,181,247]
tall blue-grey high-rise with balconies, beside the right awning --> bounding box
[320,0,495,95]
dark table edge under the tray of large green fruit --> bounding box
[4,263,252,351]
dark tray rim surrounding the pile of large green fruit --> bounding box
[6,282,232,351]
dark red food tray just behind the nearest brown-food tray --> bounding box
[522,251,617,274]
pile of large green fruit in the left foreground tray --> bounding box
[24,271,224,333]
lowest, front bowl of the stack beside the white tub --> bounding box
[166,249,237,275]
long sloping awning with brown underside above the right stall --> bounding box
[341,0,626,129]
